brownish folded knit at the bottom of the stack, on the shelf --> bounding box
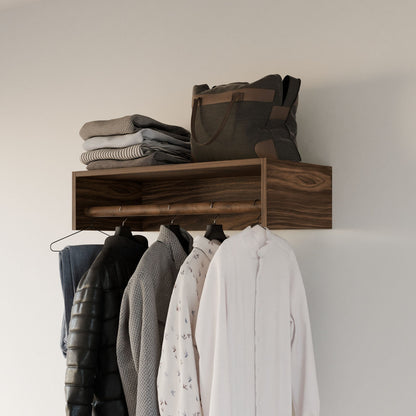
[87,152,190,170]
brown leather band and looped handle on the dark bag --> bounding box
[191,88,275,146]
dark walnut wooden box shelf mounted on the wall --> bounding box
[72,158,332,231]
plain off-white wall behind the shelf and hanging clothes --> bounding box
[0,0,416,416]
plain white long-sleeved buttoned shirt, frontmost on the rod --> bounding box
[196,225,319,416]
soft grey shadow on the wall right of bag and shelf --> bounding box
[298,74,416,231]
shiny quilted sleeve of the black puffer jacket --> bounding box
[65,270,103,416]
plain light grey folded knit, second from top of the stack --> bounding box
[82,129,191,151]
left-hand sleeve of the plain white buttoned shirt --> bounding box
[195,248,232,415]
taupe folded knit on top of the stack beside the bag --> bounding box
[79,114,190,140]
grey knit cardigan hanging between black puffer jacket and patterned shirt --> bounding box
[117,225,192,416]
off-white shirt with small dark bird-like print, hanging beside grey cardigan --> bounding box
[157,236,220,416]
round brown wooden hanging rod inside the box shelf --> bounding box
[85,199,261,217]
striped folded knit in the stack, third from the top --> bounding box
[81,143,191,165]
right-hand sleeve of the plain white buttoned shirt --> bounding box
[290,250,320,416]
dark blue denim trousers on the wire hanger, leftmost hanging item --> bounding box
[59,244,103,356]
